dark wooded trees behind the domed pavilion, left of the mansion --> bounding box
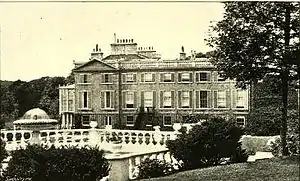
[0,77,69,127]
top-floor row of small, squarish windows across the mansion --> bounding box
[80,72,225,84]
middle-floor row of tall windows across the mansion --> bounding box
[80,90,248,109]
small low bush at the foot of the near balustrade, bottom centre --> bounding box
[138,158,174,179]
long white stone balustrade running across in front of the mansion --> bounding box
[1,129,176,151]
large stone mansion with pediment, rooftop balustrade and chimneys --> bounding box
[61,35,249,128]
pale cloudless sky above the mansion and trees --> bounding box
[0,2,224,81]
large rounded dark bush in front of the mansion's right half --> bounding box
[167,118,248,169]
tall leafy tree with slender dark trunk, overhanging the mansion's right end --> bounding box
[207,2,300,155]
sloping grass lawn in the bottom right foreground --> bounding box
[139,158,299,181]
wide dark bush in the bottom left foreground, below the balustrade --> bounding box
[4,145,110,181]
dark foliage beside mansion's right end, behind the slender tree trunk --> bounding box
[245,75,297,136]
